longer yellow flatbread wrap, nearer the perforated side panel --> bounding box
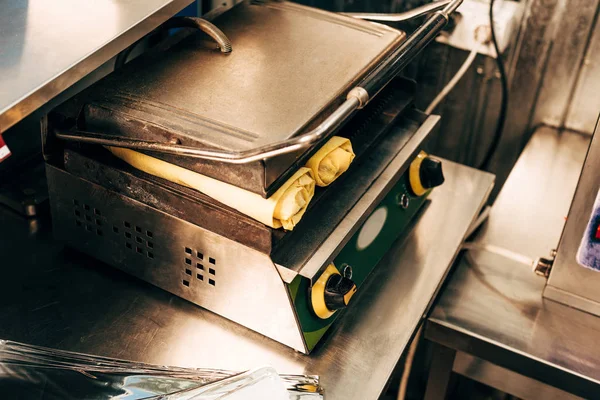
[107,147,315,231]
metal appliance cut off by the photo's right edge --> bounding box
[544,119,600,315]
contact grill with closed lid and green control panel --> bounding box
[44,1,460,353]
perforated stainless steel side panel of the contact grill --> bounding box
[47,165,306,352]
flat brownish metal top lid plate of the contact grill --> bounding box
[81,1,405,197]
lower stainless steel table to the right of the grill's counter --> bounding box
[425,128,600,399]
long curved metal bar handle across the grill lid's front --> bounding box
[54,0,463,164]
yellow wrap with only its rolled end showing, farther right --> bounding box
[306,136,354,186]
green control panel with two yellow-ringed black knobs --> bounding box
[288,152,444,351]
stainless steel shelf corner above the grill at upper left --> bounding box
[0,0,192,133]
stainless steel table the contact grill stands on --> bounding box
[0,162,494,400]
